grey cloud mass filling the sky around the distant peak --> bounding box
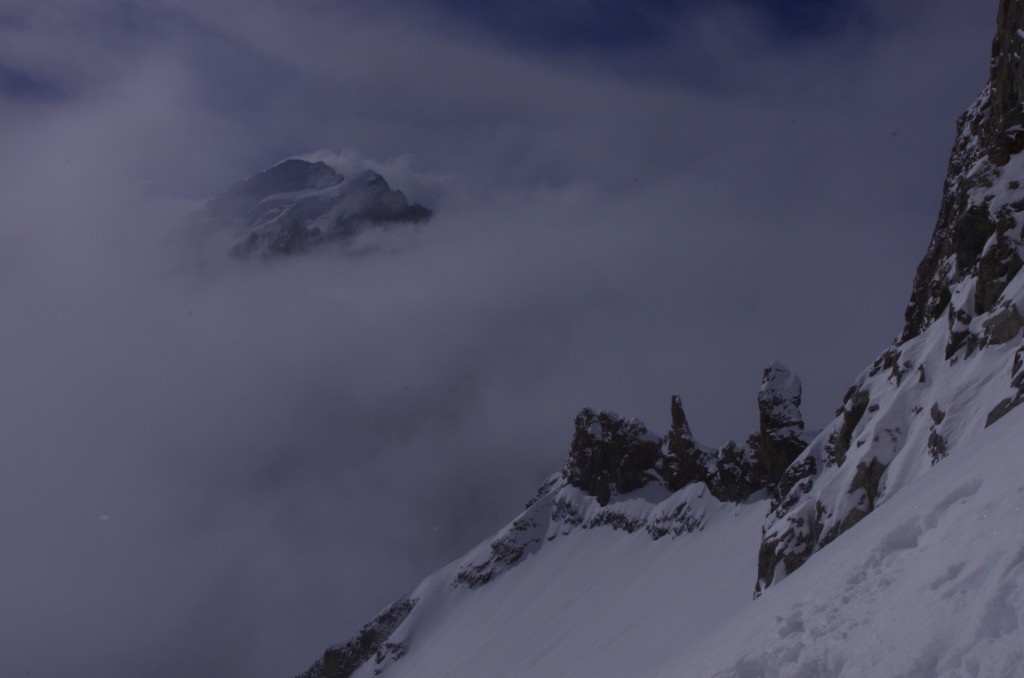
[0,0,994,676]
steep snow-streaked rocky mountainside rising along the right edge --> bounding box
[758,0,1024,590]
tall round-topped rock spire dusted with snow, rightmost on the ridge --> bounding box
[758,363,806,484]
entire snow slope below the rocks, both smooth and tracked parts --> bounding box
[342,399,1024,678]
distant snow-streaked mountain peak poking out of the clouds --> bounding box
[199,158,433,257]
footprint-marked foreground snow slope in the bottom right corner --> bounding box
[659,410,1024,678]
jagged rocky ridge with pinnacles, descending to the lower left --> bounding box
[303,363,806,678]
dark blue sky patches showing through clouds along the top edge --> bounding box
[0,0,872,102]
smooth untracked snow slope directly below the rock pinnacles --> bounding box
[354,493,765,676]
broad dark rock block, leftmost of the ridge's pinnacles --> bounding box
[562,409,662,506]
